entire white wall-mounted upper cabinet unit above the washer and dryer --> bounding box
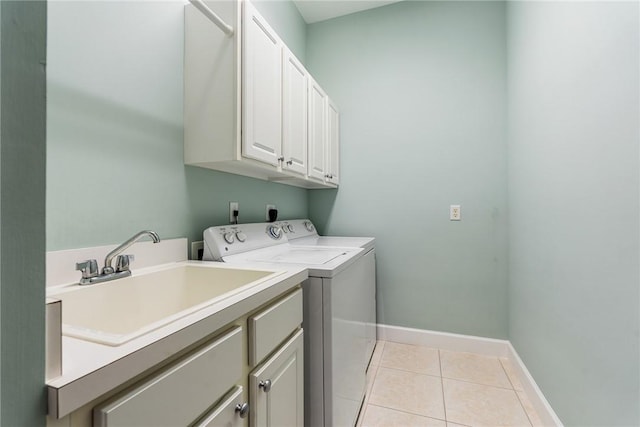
[184,0,338,188]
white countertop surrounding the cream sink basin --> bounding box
[46,261,307,418]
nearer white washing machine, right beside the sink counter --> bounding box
[203,222,375,427]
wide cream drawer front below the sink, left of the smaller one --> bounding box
[93,327,243,427]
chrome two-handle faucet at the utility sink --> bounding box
[76,230,160,285]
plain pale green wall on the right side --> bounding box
[508,2,640,426]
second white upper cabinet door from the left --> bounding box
[282,48,308,175]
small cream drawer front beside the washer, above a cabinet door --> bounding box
[248,289,302,366]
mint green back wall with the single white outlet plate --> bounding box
[307,1,507,338]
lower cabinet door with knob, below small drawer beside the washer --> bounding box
[249,329,304,427]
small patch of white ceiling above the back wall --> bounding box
[293,0,402,24]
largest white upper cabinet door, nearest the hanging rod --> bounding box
[242,2,283,166]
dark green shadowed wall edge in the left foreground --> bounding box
[0,1,47,427]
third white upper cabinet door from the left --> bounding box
[309,77,327,182]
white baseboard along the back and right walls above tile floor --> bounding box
[377,325,563,427]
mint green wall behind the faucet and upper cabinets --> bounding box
[47,1,307,250]
